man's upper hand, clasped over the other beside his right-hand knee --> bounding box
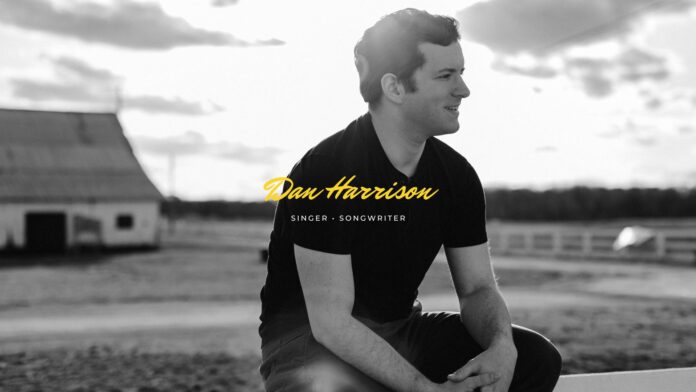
[447,339,517,392]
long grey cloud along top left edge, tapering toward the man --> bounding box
[0,0,282,50]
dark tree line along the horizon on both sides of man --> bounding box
[161,186,696,221]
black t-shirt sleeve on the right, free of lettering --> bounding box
[444,161,488,248]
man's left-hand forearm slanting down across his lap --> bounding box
[317,316,435,392]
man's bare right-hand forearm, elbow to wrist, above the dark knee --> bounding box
[460,287,512,349]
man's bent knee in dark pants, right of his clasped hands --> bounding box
[510,326,562,392]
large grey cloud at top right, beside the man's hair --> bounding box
[457,0,694,55]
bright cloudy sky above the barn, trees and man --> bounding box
[0,0,696,201]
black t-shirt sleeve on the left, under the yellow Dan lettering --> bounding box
[282,154,353,254]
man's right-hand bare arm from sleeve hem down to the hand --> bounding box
[445,243,517,392]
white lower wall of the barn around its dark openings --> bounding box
[0,202,160,249]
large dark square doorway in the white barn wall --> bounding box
[24,212,67,253]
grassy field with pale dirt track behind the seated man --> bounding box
[0,221,696,392]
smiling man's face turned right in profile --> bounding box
[402,42,469,136]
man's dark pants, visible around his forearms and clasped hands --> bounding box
[261,308,561,392]
